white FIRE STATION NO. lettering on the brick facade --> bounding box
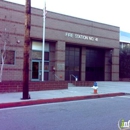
[65,32,98,41]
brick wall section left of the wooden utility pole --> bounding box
[0,1,24,81]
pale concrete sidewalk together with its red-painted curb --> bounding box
[0,81,130,108]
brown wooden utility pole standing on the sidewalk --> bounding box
[22,0,31,99]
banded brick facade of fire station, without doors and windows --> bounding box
[0,1,119,80]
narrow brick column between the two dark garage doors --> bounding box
[81,47,86,81]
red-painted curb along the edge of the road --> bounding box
[0,92,126,109]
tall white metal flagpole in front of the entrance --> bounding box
[42,0,46,81]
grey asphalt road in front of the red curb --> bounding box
[0,96,130,130]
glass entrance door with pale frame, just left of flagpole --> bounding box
[32,60,41,81]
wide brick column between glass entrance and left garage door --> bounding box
[55,41,65,80]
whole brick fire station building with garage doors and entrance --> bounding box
[0,1,120,92]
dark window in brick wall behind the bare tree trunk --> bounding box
[0,50,15,65]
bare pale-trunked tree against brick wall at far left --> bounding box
[0,13,19,82]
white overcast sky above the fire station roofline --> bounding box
[6,0,130,33]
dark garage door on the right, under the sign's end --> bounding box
[86,49,105,81]
